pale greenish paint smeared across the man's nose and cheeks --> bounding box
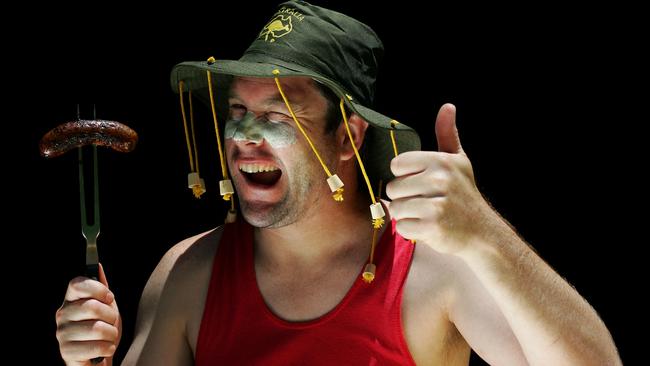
[224,112,296,149]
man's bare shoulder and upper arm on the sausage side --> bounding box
[123,228,223,364]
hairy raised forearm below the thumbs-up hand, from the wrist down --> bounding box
[459,218,620,365]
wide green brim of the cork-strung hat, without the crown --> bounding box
[170,60,420,182]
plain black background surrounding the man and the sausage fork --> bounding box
[3,2,647,364]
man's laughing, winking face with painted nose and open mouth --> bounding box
[225,77,336,227]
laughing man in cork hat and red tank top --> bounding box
[57,2,620,365]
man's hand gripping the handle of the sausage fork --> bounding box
[56,265,122,366]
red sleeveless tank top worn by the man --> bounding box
[195,220,415,366]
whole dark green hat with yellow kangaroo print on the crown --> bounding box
[171,1,420,184]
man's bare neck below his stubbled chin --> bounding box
[255,179,372,269]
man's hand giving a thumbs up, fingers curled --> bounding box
[386,104,497,254]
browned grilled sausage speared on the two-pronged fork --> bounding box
[39,120,138,158]
